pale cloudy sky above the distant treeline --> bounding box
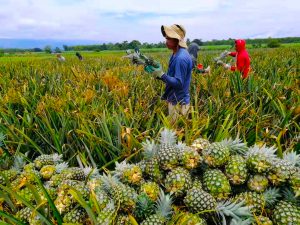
[0,0,300,43]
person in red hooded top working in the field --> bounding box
[217,39,250,79]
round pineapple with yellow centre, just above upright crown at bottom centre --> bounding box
[165,167,192,197]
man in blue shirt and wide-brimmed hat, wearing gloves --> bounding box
[145,24,193,122]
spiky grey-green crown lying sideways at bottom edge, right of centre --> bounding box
[216,199,253,225]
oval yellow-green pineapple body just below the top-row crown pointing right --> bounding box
[225,155,248,185]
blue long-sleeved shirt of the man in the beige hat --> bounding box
[161,48,193,105]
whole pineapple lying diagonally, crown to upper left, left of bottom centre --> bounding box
[101,174,137,212]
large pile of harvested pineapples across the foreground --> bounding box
[0,129,300,225]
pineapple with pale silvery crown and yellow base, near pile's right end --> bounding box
[245,145,276,173]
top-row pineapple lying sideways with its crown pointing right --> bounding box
[202,138,248,167]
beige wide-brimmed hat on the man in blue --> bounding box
[161,24,187,48]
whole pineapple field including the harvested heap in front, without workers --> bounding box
[0,46,300,225]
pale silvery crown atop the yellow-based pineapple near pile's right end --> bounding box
[245,144,277,162]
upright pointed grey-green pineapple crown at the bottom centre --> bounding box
[156,189,173,219]
